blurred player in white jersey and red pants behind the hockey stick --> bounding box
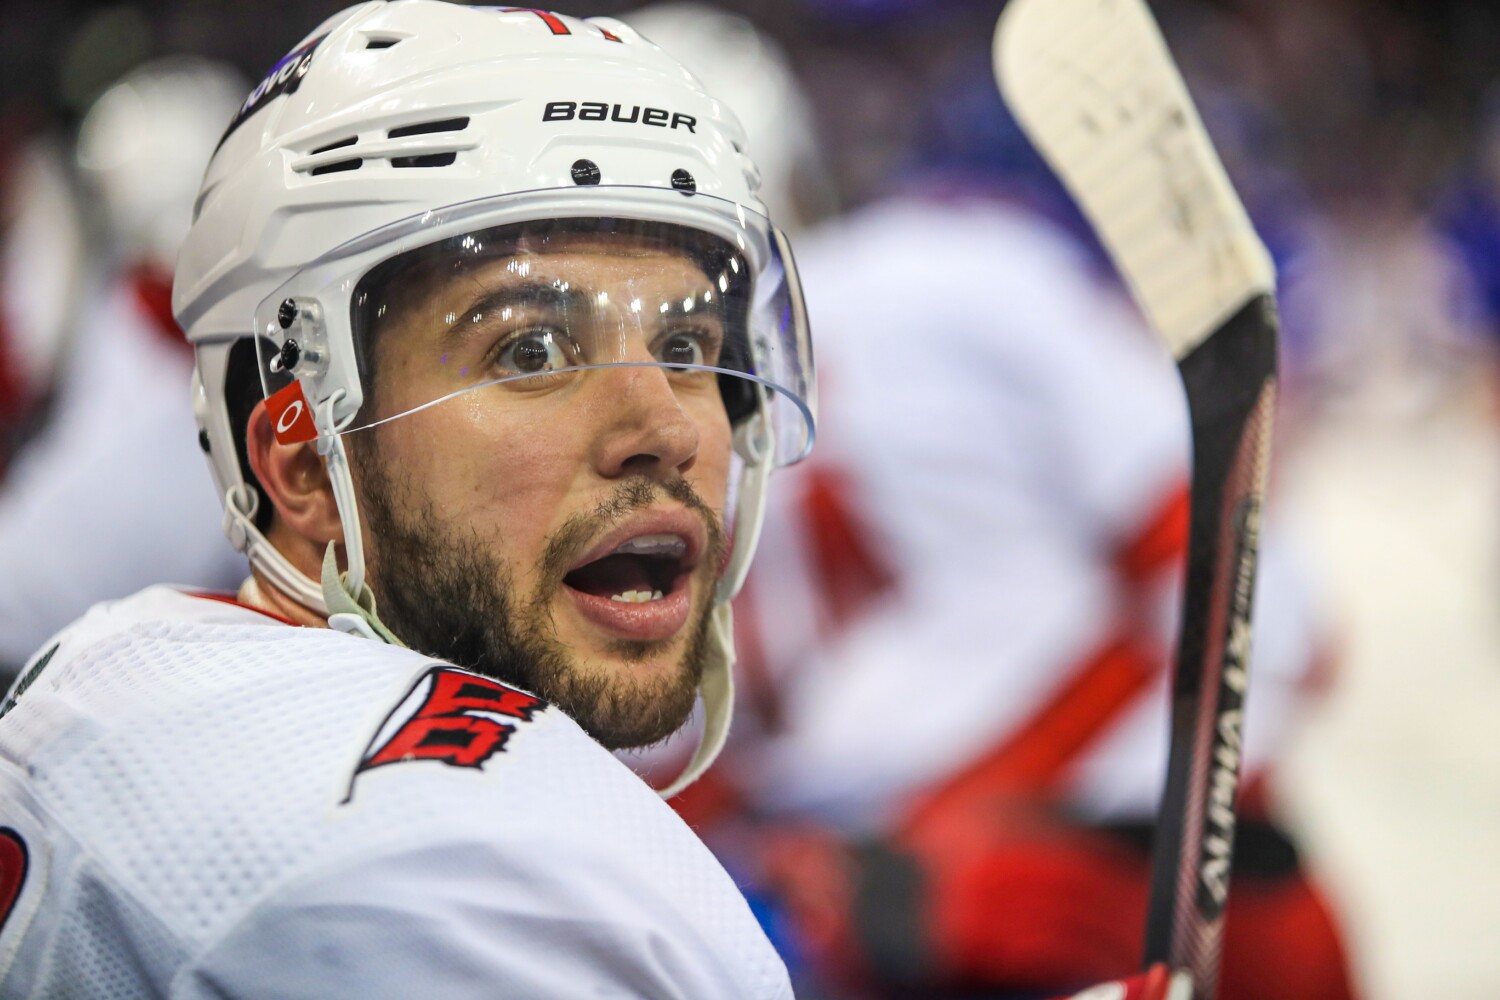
[732,196,1349,1000]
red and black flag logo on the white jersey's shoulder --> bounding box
[351,667,548,792]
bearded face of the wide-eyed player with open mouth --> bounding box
[350,235,731,745]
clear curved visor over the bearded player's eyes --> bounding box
[257,189,816,465]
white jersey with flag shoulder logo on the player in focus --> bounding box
[0,588,791,1000]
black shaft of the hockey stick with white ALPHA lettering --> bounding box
[1146,295,1277,1000]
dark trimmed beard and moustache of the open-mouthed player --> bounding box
[351,441,725,750]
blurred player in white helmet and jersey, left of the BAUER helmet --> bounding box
[0,57,245,673]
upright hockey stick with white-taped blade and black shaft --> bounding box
[995,0,1277,1000]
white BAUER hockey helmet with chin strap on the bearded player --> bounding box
[173,0,816,793]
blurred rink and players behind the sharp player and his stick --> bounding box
[0,0,1500,1000]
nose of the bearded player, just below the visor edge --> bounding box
[594,366,699,478]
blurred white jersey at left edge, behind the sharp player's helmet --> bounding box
[0,277,246,675]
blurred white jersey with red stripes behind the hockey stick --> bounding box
[737,196,1313,831]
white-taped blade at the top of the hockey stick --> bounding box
[995,0,1275,358]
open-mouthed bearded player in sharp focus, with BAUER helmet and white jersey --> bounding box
[0,0,815,1000]
